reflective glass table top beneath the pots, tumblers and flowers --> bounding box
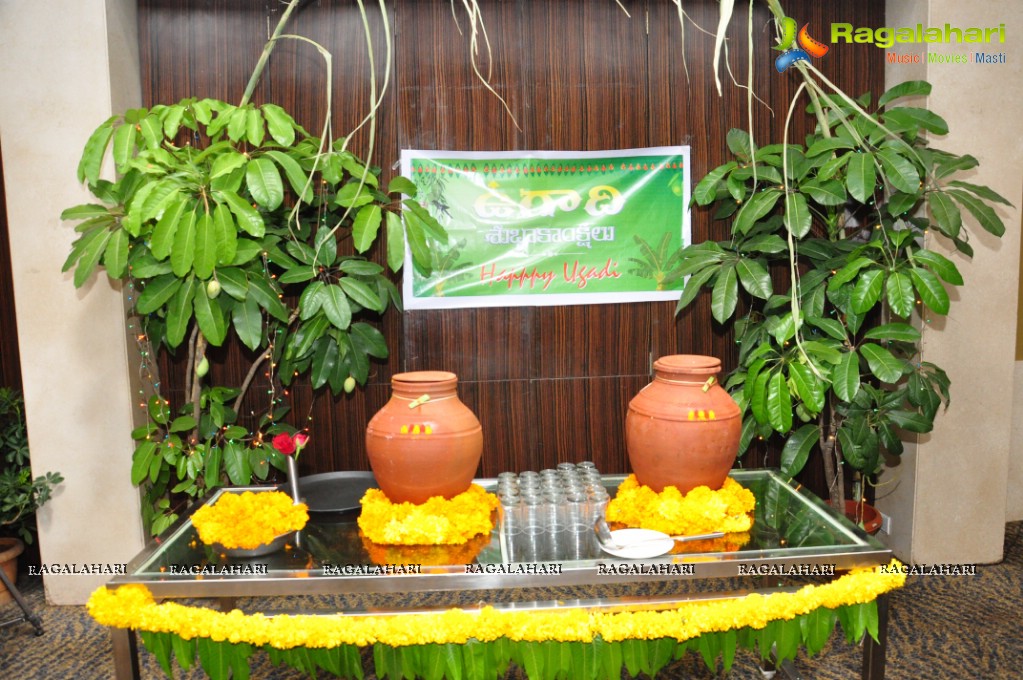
[112,469,891,596]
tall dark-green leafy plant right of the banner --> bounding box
[676,75,1008,519]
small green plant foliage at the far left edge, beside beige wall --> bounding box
[0,388,63,593]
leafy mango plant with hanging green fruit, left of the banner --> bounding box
[62,0,446,535]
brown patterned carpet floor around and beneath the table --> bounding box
[0,523,1023,680]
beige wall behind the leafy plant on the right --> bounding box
[878,0,1023,563]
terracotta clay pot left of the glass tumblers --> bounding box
[366,371,483,504]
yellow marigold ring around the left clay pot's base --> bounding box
[359,484,498,545]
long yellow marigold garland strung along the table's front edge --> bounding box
[86,559,905,649]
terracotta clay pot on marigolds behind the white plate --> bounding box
[625,354,743,494]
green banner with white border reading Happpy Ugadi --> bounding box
[402,146,690,309]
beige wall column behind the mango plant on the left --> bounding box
[0,0,143,604]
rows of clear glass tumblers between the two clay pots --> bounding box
[497,461,609,562]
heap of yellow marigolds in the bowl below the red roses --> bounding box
[191,491,309,550]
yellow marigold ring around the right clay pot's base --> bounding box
[608,474,756,536]
